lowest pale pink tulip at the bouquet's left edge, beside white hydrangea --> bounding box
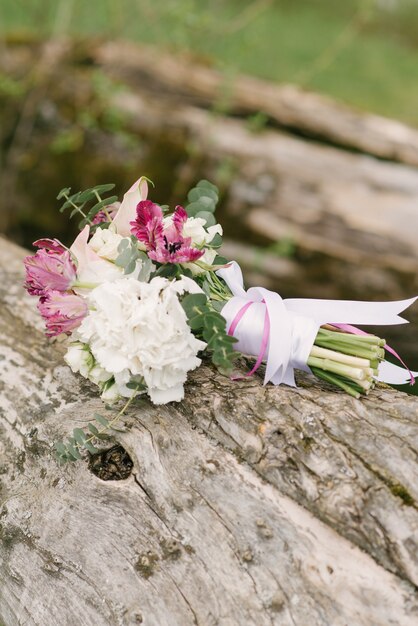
[38,291,88,337]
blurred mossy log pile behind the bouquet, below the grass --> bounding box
[0,42,418,298]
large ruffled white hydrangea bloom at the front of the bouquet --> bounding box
[76,277,206,404]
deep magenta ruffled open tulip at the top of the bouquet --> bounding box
[131,200,204,263]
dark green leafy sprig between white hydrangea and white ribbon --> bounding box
[181,293,238,374]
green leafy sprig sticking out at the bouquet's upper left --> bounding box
[57,184,118,230]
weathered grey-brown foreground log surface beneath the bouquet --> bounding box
[0,235,418,626]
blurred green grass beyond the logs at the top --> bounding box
[0,0,418,126]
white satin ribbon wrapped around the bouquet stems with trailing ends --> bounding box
[217,261,418,387]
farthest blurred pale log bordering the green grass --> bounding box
[91,41,418,166]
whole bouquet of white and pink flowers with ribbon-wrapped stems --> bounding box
[24,177,415,461]
